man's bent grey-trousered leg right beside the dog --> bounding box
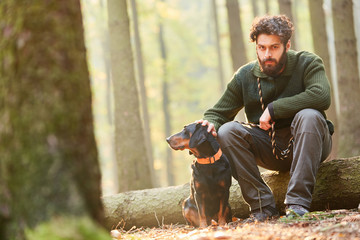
[218,122,278,220]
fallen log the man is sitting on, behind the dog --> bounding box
[103,156,360,229]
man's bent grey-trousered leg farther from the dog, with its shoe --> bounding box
[285,109,332,215]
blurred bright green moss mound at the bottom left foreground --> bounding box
[25,217,111,240]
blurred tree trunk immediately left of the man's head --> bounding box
[226,0,247,71]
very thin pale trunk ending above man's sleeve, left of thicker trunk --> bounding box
[211,0,225,92]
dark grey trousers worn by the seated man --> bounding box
[218,109,332,210]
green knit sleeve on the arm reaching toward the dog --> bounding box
[204,74,243,131]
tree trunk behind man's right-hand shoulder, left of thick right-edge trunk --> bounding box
[309,0,339,159]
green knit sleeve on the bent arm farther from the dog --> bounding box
[272,56,331,120]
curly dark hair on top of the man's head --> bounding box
[250,15,294,45]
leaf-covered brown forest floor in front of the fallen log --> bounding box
[111,209,360,240]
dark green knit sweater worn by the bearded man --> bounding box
[204,50,331,130]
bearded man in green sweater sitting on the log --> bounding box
[200,15,333,221]
